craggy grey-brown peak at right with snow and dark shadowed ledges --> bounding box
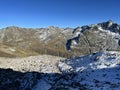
[67,21,120,53]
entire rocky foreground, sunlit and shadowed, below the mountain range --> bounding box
[0,52,120,90]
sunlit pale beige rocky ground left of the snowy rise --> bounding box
[0,55,63,73]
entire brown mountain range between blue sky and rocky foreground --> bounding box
[0,20,120,57]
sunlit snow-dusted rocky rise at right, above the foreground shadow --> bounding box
[58,51,120,72]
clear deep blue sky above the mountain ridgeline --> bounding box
[0,0,120,28]
